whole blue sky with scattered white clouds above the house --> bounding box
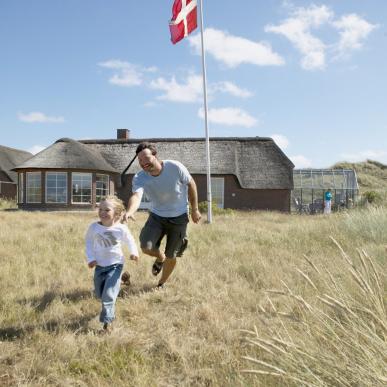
[0,0,387,168]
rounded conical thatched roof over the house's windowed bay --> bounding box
[13,138,120,173]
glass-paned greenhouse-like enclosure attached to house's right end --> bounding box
[292,169,359,214]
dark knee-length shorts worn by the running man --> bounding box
[140,212,189,258]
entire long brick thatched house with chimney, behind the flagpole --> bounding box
[14,130,294,211]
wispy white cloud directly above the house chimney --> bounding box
[98,59,157,87]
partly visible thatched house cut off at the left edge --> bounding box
[0,145,32,200]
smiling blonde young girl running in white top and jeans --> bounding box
[86,196,138,331]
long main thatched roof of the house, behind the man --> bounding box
[81,137,294,189]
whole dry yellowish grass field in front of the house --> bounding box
[0,207,387,386]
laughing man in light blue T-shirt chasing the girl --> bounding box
[125,142,201,287]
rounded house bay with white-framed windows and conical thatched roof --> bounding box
[14,138,119,209]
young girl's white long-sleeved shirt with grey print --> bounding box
[86,222,138,266]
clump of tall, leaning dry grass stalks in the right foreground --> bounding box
[243,237,387,386]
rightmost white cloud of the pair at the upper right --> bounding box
[332,14,378,57]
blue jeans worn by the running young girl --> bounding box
[94,264,123,324]
